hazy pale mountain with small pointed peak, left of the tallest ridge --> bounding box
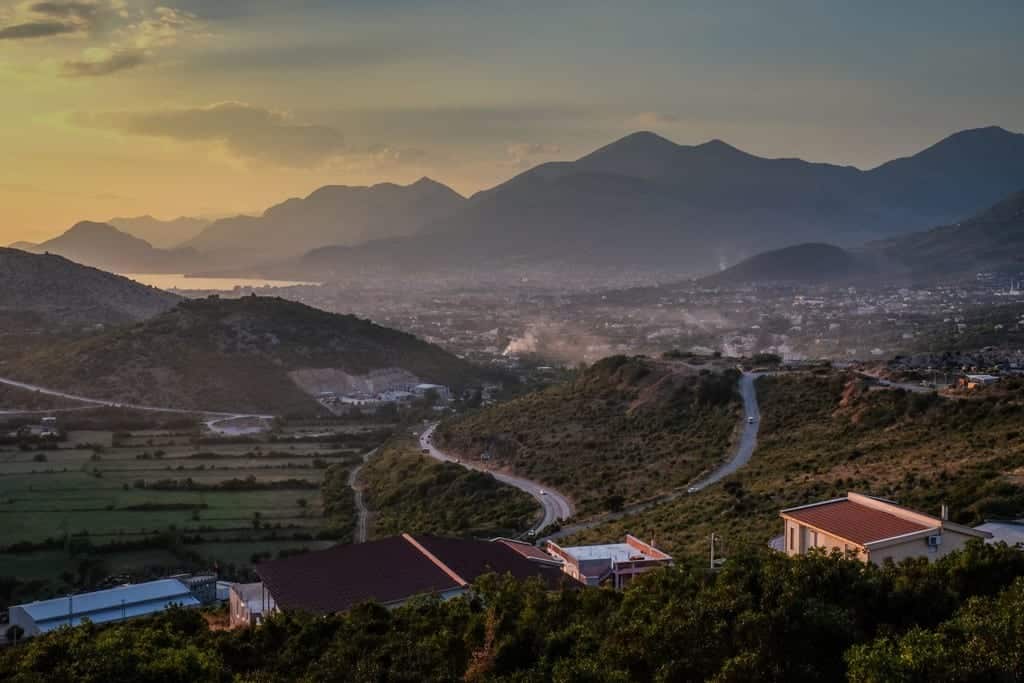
[186,178,464,258]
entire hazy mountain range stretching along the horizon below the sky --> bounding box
[14,127,1024,281]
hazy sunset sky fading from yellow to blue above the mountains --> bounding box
[0,0,1024,244]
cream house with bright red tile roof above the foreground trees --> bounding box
[779,493,991,564]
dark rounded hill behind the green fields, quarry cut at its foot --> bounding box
[6,297,476,413]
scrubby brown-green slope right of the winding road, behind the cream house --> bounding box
[573,372,1024,554]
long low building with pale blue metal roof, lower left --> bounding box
[10,579,201,637]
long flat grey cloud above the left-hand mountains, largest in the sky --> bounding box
[74,101,346,168]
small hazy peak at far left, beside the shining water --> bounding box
[32,221,199,272]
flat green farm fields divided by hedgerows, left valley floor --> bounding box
[0,425,391,603]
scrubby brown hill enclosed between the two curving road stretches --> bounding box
[435,356,740,515]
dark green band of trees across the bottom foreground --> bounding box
[0,544,1024,683]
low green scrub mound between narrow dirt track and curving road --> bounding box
[359,441,540,538]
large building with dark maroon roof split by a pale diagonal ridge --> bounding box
[238,533,563,626]
